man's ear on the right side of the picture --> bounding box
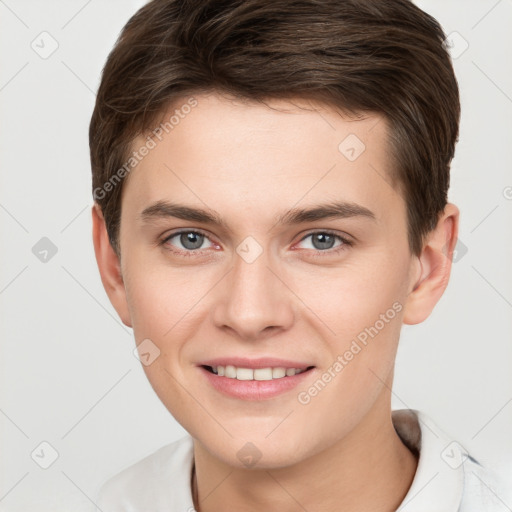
[403,203,459,325]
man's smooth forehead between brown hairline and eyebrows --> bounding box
[123,93,403,230]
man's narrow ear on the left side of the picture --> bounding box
[92,203,132,327]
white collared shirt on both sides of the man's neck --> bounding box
[97,409,512,512]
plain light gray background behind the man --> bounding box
[0,0,512,512]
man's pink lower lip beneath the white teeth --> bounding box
[199,366,312,400]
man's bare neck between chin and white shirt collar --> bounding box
[193,393,417,512]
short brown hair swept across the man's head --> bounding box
[89,0,460,255]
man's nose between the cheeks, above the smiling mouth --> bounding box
[213,245,294,341]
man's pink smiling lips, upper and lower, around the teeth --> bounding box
[198,357,314,400]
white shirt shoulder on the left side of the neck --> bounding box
[97,436,193,512]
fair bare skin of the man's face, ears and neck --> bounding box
[92,93,459,512]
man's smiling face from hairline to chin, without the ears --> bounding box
[112,94,417,468]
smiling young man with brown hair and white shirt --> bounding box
[90,0,503,512]
